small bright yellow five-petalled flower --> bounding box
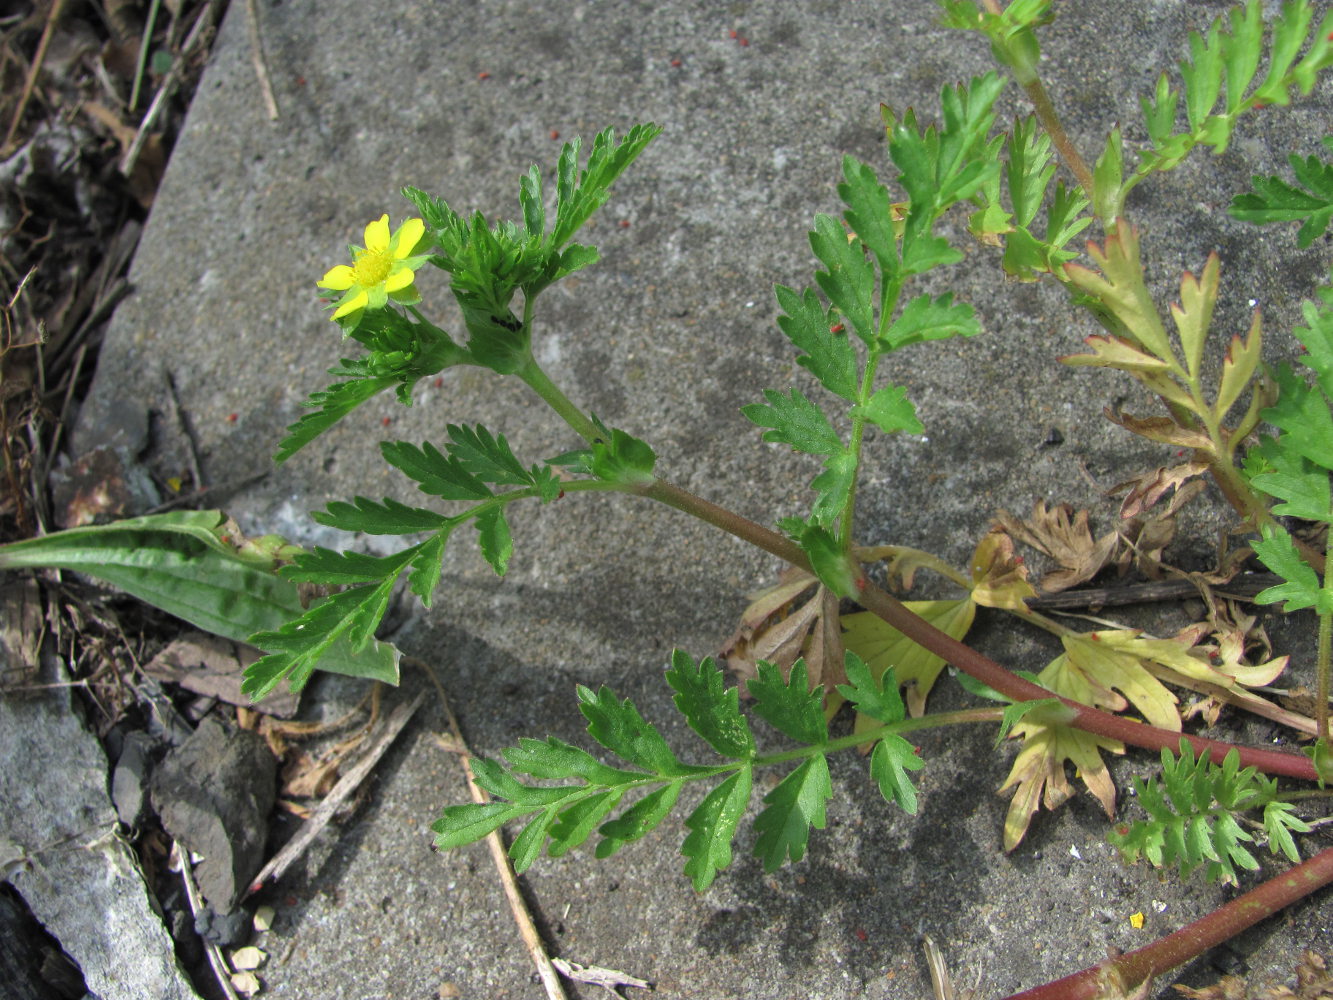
[316,215,429,327]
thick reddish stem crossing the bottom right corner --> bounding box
[1008,848,1333,1000]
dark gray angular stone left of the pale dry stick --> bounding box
[152,719,277,913]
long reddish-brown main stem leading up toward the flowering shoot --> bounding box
[634,479,1316,781]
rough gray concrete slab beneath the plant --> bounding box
[70,0,1333,1000]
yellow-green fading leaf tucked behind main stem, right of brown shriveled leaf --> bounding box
[842,597,977,727]
